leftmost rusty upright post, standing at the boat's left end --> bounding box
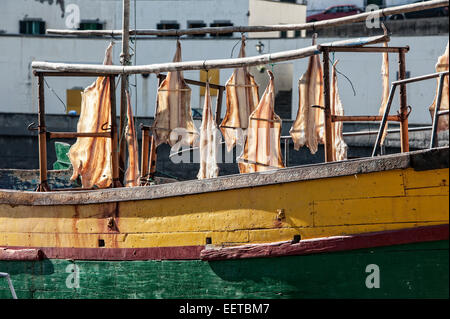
[36,75,50,192]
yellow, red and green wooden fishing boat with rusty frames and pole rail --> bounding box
[0,1,449,299]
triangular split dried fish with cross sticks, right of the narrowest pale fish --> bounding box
[238,71,284,173]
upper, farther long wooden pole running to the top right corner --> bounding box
[47,0,449,36]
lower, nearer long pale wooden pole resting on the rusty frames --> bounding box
[31,35,390,75]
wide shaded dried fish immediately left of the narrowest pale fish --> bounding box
[153,41,198,147]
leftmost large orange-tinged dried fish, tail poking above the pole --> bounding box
[69,43,114,188]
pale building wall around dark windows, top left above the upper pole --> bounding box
[0,0,249,33]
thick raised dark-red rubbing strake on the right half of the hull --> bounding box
[201,224,448,261]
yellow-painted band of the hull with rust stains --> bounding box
[0,168,449,248]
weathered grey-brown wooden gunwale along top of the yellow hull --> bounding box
[0,146,449,206]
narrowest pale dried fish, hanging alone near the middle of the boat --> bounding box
[197,83,219,179]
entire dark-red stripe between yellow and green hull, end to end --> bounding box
[0,224,449,261]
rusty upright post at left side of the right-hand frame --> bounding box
[323,48,333,162]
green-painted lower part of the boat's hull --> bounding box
[0,240,449,299]
